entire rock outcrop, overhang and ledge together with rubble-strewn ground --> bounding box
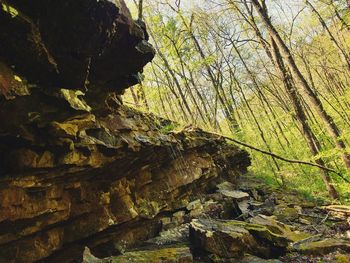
[0,0,350,263]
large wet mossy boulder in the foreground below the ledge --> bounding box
[190,216,310,258]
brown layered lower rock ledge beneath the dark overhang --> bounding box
[0,90,249,262]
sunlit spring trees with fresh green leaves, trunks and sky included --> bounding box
[124,0,350,201]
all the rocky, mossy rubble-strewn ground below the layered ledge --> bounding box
[84,176,350,263]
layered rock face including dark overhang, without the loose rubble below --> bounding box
[0,0,249,262]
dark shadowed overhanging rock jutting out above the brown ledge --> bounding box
[0,0,154,93]
